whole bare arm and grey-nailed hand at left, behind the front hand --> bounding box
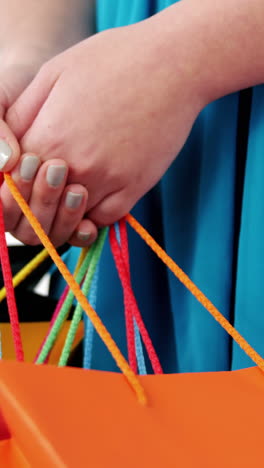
[0,0,97,246]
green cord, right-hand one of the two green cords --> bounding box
[59,228,108,366]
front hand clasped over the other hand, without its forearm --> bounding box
[7,15,201,225]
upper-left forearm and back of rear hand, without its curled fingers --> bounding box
[0,0,95,171]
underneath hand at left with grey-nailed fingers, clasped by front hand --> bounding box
[0,49,97,246]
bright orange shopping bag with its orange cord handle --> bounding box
[0,174,264,468]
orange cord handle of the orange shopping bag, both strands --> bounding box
[4,173,264,404]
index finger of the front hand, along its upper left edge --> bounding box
[5,64,58,140]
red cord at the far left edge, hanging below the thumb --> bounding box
[0,173,24,361]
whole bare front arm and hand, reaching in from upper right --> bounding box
[3,0,264,239]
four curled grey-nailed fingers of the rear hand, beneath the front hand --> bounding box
[1,154,97,246]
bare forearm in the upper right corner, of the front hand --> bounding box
[150,0,264,104]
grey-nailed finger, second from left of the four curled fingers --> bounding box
[11,159,68,245]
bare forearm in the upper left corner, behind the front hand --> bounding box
[0,0,95,58]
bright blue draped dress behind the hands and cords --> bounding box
[52,0,264,372]
